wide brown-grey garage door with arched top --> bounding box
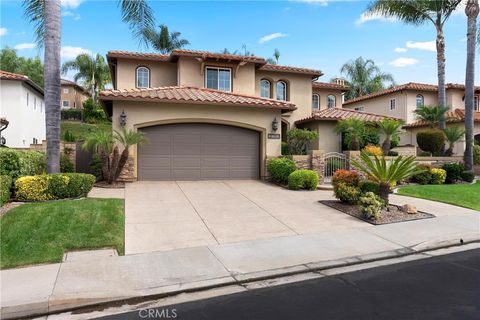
[138,123,260,180]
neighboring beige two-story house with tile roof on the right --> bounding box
[343,82,480,154]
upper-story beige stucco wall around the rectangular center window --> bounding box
[178,57,255,95]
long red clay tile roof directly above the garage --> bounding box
[99,86,296,111]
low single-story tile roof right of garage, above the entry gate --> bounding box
[295,108,395,124]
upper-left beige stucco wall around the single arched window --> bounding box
[116,59,177,89]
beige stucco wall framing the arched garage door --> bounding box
[112,101,281,177]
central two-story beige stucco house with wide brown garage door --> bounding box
[100,50,364,180]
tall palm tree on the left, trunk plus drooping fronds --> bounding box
[23,0,155,173]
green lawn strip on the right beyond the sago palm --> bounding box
[398,181,480,211]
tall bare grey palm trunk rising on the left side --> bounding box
[44,0,61,173]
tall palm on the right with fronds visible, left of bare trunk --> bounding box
[367,0,461,129]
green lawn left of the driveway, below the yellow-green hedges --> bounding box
[0,198,125,269]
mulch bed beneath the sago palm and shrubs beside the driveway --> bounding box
[319,200,435,225]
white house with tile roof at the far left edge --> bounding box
[0,71,45,148]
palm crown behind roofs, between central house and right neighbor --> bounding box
[340,57,395,100]
